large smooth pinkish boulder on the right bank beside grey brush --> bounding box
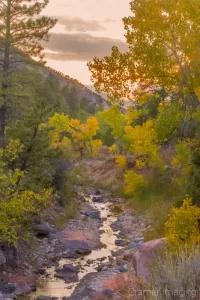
[133,238,166,281]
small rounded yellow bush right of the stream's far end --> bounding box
[124,170,146,196]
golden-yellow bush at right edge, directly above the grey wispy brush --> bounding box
[166,196,200,248]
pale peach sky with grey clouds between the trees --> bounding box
[43,0,130,85]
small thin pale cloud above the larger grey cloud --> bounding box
[56,16,105,32]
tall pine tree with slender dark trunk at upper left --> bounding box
[0,0,56,140]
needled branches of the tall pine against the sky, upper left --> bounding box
[0,0,56,61]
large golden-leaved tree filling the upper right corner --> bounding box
[88,0,200,107]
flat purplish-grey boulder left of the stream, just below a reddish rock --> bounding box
[65,240,92,255]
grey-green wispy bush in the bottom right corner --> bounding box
[149,246,200,300]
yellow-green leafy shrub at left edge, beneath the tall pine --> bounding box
[0,140,53,247]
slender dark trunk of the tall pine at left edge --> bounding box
[0,0,11,146]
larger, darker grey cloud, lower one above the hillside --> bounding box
[43,33,127,61]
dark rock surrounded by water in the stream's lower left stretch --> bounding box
[55,265,79,283]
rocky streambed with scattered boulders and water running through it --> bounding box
[0,188,149,300]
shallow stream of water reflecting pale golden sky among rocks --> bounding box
[30,195,122,299]
